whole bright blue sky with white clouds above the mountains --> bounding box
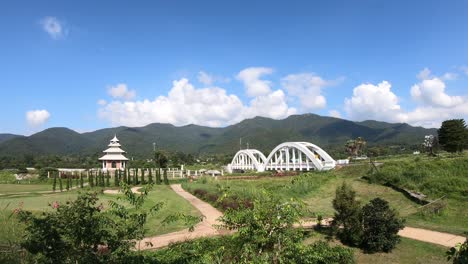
[0,1,468,134]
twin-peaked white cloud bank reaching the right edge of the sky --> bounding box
[345,68,468,127]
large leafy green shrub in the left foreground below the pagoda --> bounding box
[18,184,162,263]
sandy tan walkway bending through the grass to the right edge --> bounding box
[105,184,466,250]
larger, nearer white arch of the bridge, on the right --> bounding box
[264,142,336,170]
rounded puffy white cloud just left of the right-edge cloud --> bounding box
[345,81,402,122]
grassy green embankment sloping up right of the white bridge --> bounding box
[183,156,468,234]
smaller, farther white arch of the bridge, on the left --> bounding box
[230,149,266,172]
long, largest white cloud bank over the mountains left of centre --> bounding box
[98,78,295,126]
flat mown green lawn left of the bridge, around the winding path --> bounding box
[0,185,200,244]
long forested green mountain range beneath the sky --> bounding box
[0,114,437,157]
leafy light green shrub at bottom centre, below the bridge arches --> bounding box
[221,192,301,262]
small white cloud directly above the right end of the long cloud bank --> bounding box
[236,67,273,97]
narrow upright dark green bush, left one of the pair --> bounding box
[332,182,363,246]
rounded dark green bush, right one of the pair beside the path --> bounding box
[361,198,404,253]
